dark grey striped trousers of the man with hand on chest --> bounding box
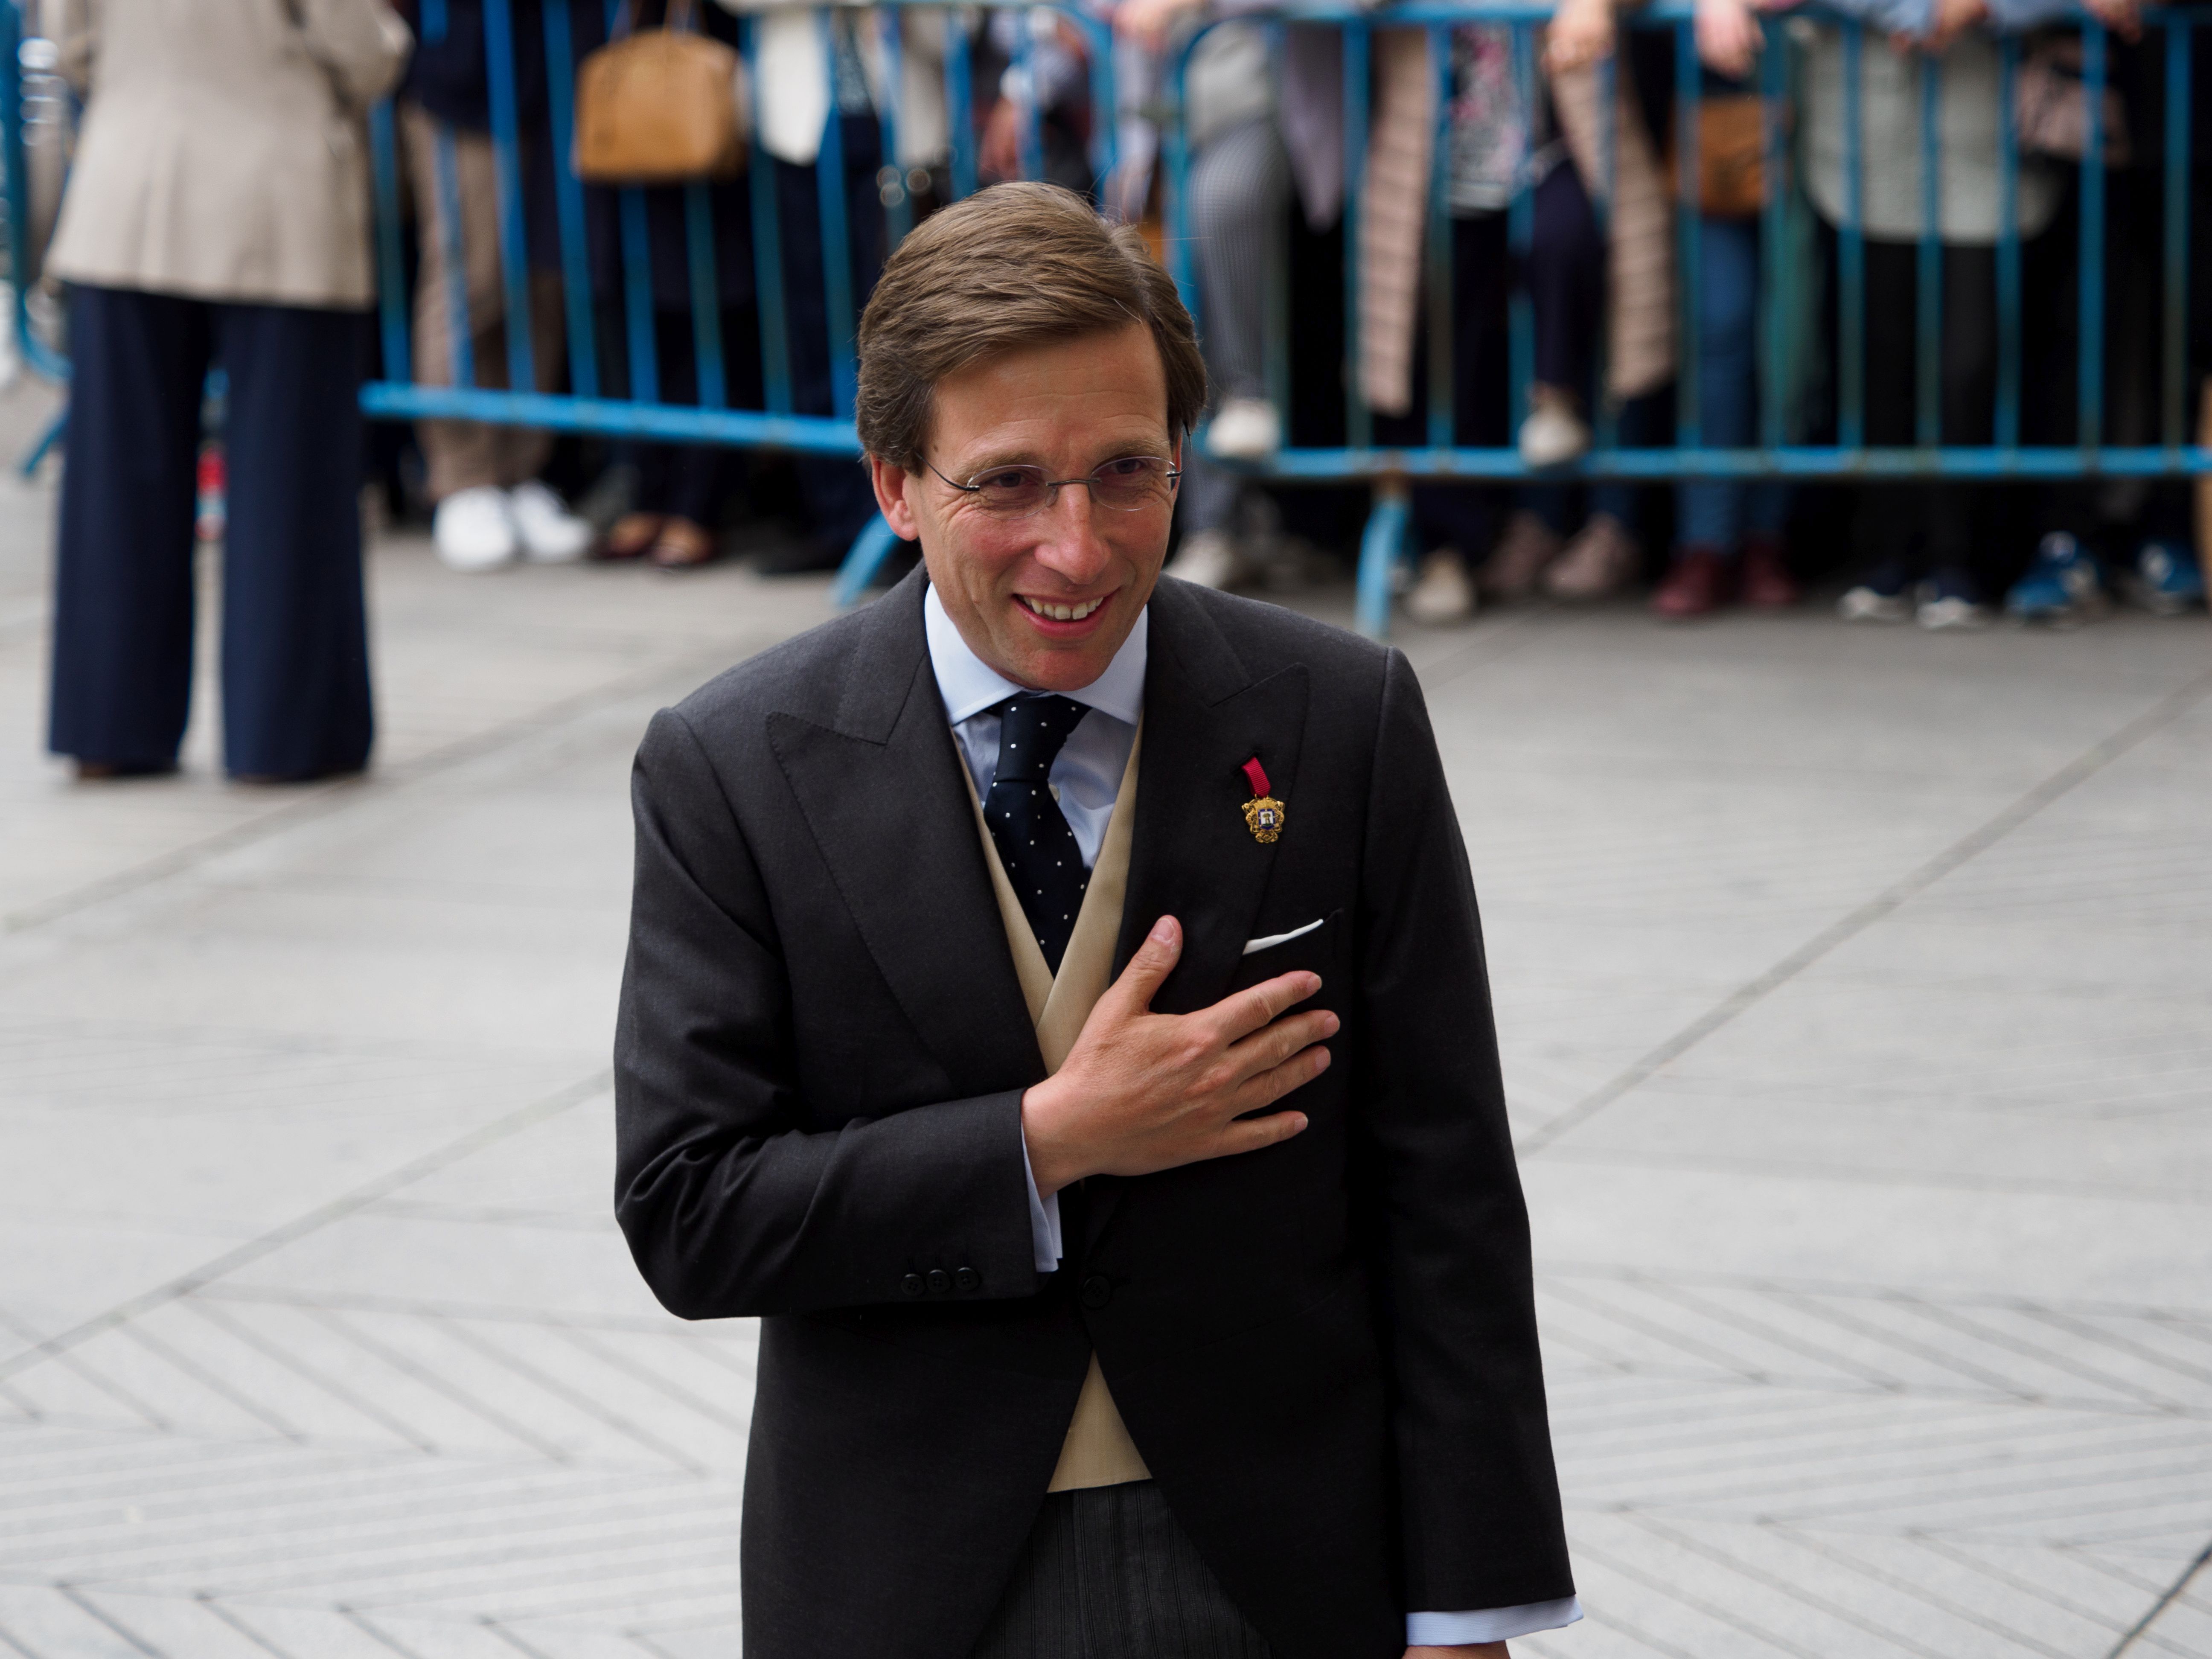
[973,1480,1267,1659]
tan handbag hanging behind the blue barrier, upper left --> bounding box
[575,0,750,183]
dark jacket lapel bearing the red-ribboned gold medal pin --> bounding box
[1089,582,1307,1239]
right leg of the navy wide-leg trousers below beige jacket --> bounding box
[215,305,374,781]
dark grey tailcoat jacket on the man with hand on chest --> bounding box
[615,573,1573,1659]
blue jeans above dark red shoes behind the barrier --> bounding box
[1674,217,1790,553]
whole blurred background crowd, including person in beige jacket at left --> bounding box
[38,0,2212,779]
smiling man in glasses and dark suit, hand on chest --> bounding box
[617,186,1579,1659]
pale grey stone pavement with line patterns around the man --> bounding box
[0,376,2212,1659]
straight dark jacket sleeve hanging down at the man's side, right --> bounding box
[1360,650,1575,1608]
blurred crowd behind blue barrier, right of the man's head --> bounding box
[1150,0,2212,628]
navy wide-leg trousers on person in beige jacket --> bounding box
[49,288,372,779]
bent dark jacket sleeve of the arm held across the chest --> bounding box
[615,710,1037,1318]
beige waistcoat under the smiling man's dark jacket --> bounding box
[960,728,1153,1491]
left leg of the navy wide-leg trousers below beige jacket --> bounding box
[47,285,210,772]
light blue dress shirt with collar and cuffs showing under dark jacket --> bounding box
[923,586,1582,1648]
